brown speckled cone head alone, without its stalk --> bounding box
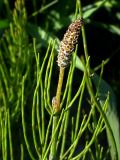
[57,19,83,68]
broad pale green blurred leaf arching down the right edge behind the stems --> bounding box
[76,57,120,160]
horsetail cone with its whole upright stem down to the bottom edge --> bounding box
[50,18,83,159]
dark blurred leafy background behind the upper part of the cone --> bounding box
[0,0,120,116]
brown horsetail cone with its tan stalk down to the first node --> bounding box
[53,19,83,112]
